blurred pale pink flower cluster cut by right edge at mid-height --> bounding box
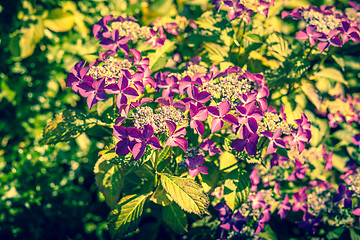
[324,95,360,128]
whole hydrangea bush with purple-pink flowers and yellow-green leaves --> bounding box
[43,0,360,239]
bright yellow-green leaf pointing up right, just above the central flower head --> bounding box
[148,40,176,72]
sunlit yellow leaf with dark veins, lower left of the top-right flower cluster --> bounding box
[266,32,291,61]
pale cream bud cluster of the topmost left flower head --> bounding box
[111,21,151,41]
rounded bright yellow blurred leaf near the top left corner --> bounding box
[44,8,75,32]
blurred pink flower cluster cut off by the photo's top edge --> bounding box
[213,0,274,23]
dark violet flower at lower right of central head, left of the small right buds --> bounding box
[231,127,259,155]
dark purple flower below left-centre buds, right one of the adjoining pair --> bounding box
[129,125,162,161]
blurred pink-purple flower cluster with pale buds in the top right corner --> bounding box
[281,3,360,52]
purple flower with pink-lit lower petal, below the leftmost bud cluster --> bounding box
[79,78,107,109]
